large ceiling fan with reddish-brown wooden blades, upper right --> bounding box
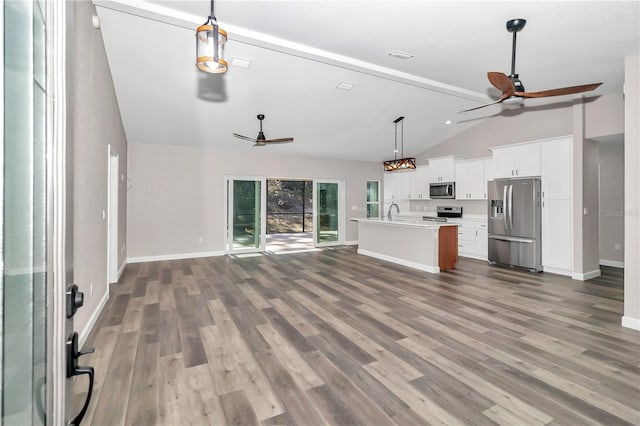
[458,19,602,113]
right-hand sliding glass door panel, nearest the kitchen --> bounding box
[313,180,344,247]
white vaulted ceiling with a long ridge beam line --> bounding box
[94,0,640,161]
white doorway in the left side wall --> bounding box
[107,144,120,282]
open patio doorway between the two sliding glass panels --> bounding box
[267,179,315,254]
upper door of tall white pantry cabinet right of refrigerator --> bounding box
[541,137,573,200]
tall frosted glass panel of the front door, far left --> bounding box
[0,1,47,425]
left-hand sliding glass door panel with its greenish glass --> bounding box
[226,177,267,253]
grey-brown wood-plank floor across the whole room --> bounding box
[76,247,640,426]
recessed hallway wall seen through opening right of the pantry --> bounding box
[599,140,625,265]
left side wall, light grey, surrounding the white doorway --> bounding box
[67,1,127,344]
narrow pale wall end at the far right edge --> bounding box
[622,56,640,330]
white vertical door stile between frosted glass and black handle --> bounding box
[44,2,73,424]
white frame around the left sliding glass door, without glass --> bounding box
[223,175,267,254]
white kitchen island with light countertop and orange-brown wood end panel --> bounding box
[351,218,458,273]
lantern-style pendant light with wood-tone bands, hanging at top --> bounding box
[196,0,228,74]
